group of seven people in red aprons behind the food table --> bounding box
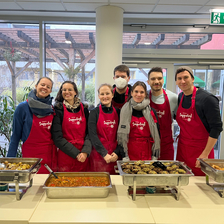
[7,65,222,175]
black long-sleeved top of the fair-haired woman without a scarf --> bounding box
[88,105,124,157]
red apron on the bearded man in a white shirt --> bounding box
[149,89,174,160]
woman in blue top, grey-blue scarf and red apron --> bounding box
[7,77,55,173]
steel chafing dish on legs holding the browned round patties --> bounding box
[117,160,194,200]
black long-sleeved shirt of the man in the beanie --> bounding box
[178,88,223,139]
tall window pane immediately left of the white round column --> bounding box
[45,24,95,106]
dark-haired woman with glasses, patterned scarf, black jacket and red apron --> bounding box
[51,81,92,172]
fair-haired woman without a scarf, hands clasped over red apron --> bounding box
[88,84,120,174]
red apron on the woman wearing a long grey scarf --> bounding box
[128,116,154,160]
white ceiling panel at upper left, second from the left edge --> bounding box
[18,2,65,11]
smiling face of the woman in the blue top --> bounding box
[35,78,52,98]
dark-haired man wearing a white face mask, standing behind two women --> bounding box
[112,65,131,109]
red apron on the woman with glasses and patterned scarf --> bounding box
[58,103,88,172]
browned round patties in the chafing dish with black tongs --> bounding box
[121,160,186,174]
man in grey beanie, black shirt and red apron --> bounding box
[175,66,222,176]
